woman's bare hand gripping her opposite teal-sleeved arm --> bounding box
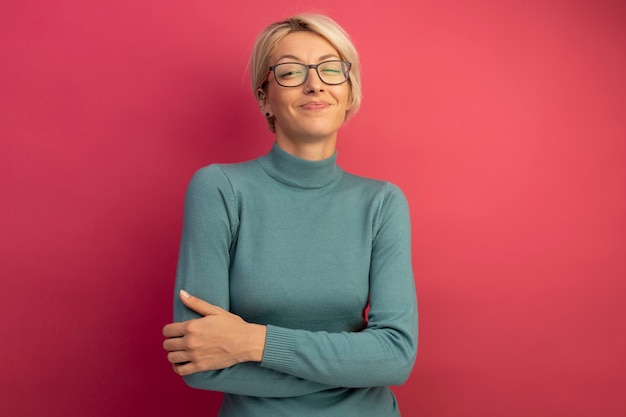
[163,290,267,376]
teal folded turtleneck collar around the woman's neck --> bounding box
[258,142,343,189]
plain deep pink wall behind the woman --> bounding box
[0,0,626,417]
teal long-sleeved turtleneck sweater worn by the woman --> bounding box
[174,144,417,417]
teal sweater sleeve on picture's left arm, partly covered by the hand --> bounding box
[174,165,332,397]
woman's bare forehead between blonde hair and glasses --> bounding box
[269,32,340,63]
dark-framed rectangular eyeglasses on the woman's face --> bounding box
[263,60,352,87]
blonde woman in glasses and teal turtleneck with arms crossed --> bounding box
[163,15,417,417]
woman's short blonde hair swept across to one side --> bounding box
[250,13,361,132]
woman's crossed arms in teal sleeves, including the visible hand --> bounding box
[158,169,417,397]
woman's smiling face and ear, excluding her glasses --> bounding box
[259,32,350,142]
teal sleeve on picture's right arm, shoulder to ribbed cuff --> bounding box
[261,183,417,388]
